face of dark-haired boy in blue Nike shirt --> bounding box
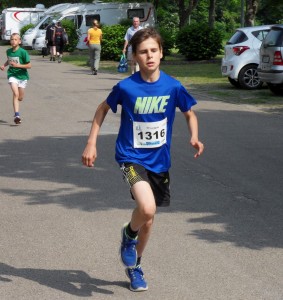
[133,38,163,73]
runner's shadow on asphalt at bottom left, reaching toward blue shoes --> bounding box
[0,263,128,297]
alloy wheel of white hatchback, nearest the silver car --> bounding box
[239,64,263,90]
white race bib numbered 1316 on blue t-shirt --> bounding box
[133,118,167,148]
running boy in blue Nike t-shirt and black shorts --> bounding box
[82,28,204,291]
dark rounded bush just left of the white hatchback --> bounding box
[176,23,223,60]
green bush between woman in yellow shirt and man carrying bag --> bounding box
[101,25,128,61]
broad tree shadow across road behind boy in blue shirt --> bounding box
[0,111,283,250]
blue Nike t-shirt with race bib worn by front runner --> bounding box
[106,71,196,173]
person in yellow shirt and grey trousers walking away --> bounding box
[87,20,102,75]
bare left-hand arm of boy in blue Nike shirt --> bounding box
[82,100,110,167]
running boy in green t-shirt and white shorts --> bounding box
[0,33,31,124]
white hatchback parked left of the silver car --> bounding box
[221,25,271,90]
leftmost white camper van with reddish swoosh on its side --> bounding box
[0,4,46,41]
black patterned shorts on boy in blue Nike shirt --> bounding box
[121,163,170,207]
